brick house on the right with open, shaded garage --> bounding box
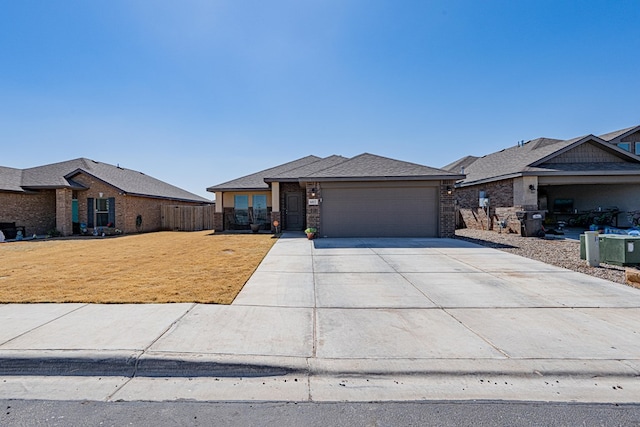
[443,126,640,233]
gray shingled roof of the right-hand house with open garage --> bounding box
[461,135,640,186]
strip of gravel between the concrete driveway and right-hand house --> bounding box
[456,228,626,283]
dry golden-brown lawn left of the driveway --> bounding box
[0,231,276,304]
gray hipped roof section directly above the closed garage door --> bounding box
[300,153,464,181]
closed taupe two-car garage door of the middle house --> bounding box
[321,183,439,237]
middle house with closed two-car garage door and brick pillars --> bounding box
[207,153,464,237]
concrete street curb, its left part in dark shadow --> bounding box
[0,354,640,378]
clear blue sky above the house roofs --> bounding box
[0,0,640,199]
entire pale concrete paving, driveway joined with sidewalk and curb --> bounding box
[0,234,640,402]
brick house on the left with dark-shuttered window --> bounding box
[0,158,213,238]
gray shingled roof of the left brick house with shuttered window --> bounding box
[2,158,211,203]
